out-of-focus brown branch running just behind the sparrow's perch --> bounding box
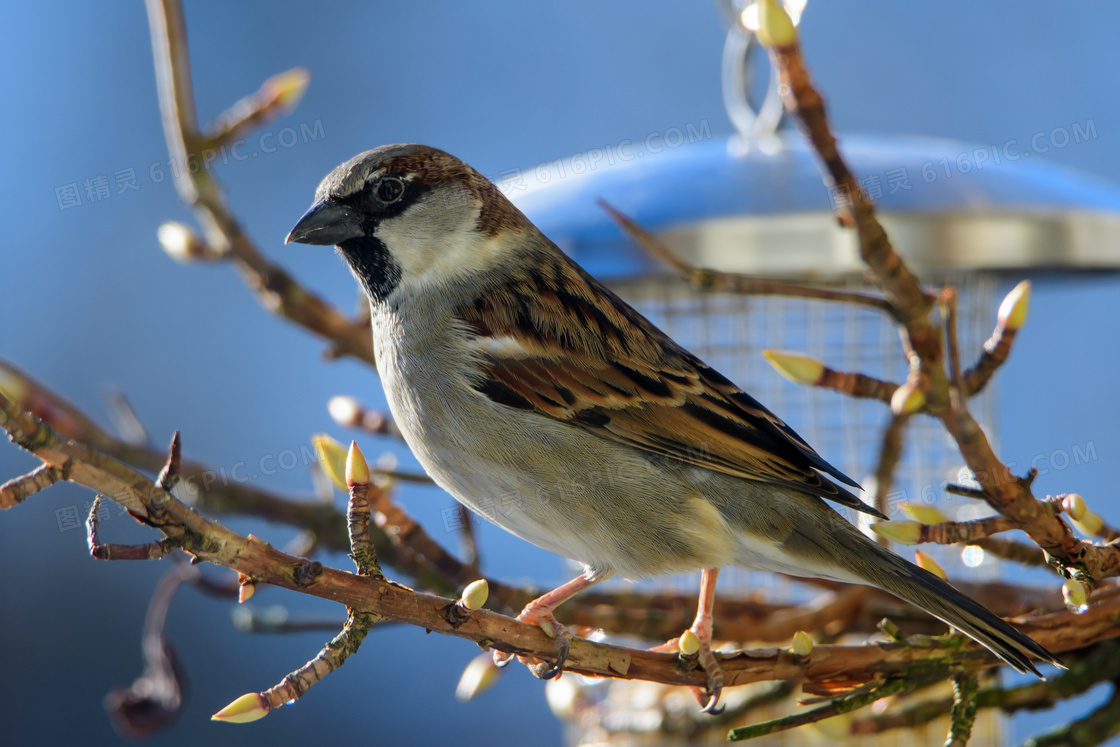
[0,353,1062,644]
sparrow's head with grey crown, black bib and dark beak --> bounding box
[286,144,532,301]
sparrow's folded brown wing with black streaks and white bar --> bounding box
[459,250,885,519]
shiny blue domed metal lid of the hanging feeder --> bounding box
[511,131,1120,281]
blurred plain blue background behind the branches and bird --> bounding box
[0,0,1120,745]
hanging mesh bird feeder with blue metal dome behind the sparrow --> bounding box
[500,2,1120,744]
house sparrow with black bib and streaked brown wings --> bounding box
[287,144,1060,710]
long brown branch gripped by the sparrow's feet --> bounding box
[0,395,1120,712]
